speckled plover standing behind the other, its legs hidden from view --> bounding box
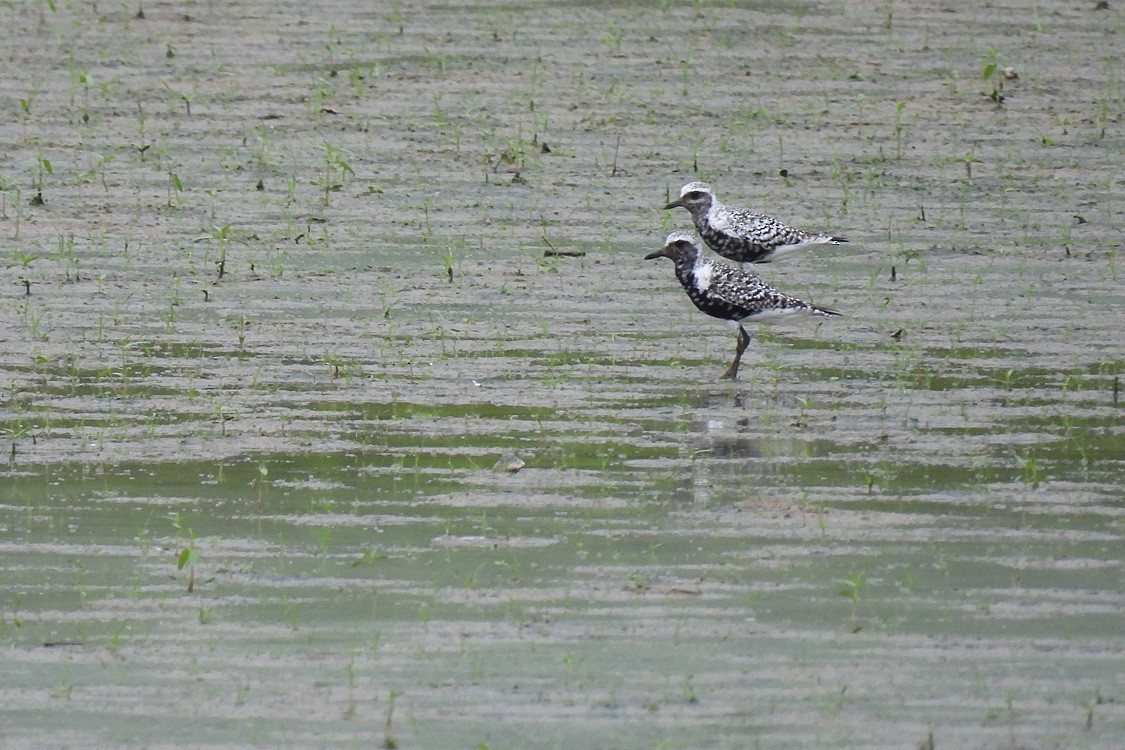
[664,182,847,263]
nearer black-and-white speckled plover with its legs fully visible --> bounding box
[645,231,839,380]
